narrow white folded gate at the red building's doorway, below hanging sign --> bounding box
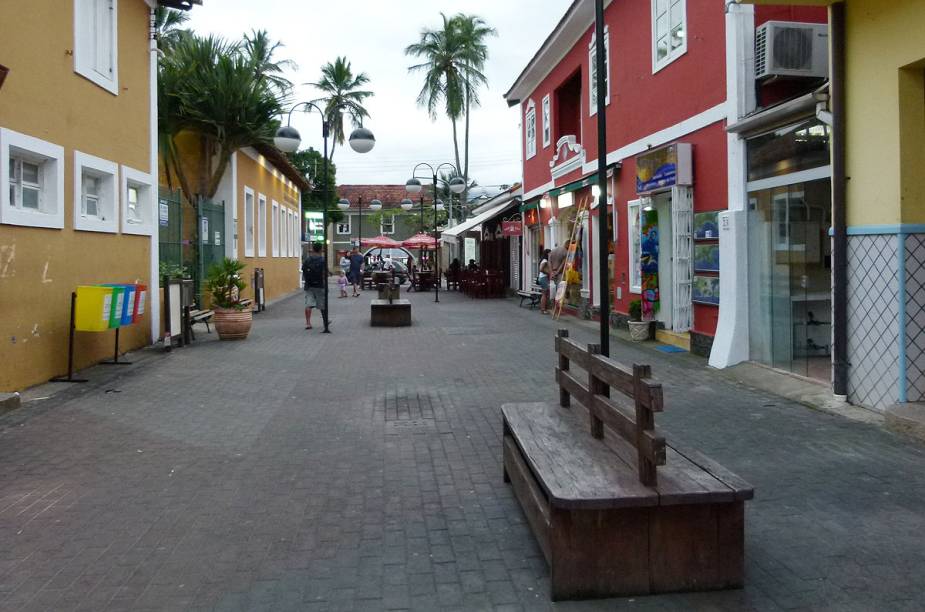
[671,187,694,332]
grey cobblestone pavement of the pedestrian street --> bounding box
[0,286,925,610]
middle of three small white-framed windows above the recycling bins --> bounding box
[74,151,119,233]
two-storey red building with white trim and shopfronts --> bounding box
[505,0,824,355]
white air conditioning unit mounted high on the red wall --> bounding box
[755,21,829,80]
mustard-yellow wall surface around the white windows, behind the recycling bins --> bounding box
[0,0,150,391]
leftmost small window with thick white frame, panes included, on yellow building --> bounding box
[0,128,64,229]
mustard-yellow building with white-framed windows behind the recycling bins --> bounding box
[0,0,188,391]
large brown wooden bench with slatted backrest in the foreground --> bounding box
[501,330,753,600]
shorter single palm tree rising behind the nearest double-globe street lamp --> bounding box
[307,57,373,159]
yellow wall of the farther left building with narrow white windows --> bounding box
[235,151,301,300]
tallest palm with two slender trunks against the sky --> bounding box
[405,13,495,204]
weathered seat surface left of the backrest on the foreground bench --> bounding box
[501,403,658,509]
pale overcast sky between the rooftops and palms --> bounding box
[191,0,571,185]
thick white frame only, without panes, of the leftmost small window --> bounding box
[0,128,64,229]
